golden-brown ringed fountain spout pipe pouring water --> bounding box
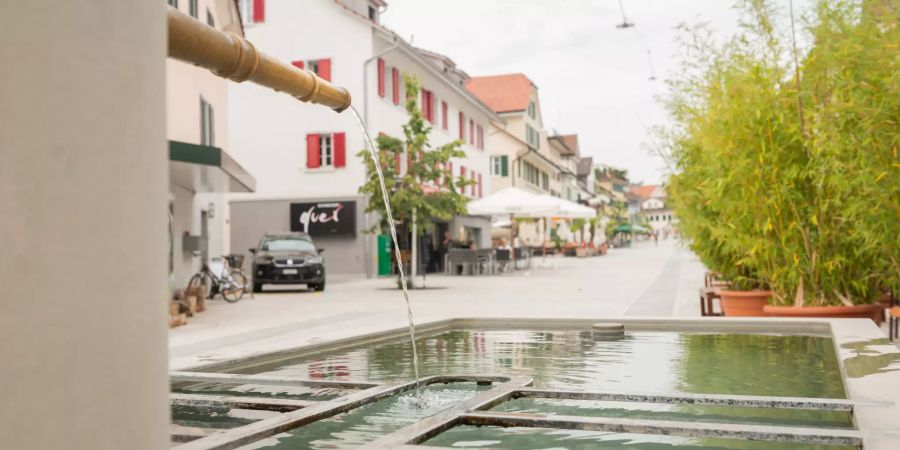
[168,6,351,112]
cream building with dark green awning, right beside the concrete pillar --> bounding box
[166,0,255,290]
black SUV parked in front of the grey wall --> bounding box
[250,233,325,292]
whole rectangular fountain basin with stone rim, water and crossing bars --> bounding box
[169,318,900,448]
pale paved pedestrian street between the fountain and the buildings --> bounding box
[169,240,703,369]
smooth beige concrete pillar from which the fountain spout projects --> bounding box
[0,0,168,449]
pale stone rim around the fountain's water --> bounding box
[178,317,900,450]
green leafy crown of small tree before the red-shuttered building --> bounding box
[357,76,473,239]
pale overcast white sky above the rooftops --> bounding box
[382,0,808,184]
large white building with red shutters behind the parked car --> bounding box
[229,0,499,275]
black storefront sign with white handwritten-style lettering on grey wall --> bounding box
[291,201,356,237]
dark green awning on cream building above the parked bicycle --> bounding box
[169,141,256,192]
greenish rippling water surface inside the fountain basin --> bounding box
[195,330,851,449]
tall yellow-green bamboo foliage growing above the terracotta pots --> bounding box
[662,0,900,306]
